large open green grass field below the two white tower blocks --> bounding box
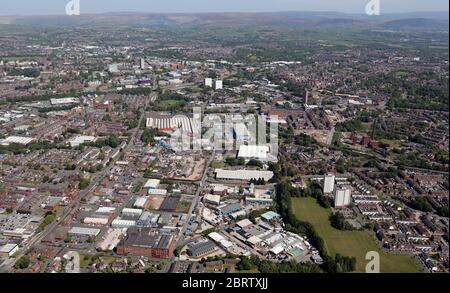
[292,198,423,273]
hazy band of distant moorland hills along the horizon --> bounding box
[0,11,448,31]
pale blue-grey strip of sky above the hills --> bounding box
[0,0,449,16]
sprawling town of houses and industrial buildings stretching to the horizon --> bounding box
[0,9,449,273]
